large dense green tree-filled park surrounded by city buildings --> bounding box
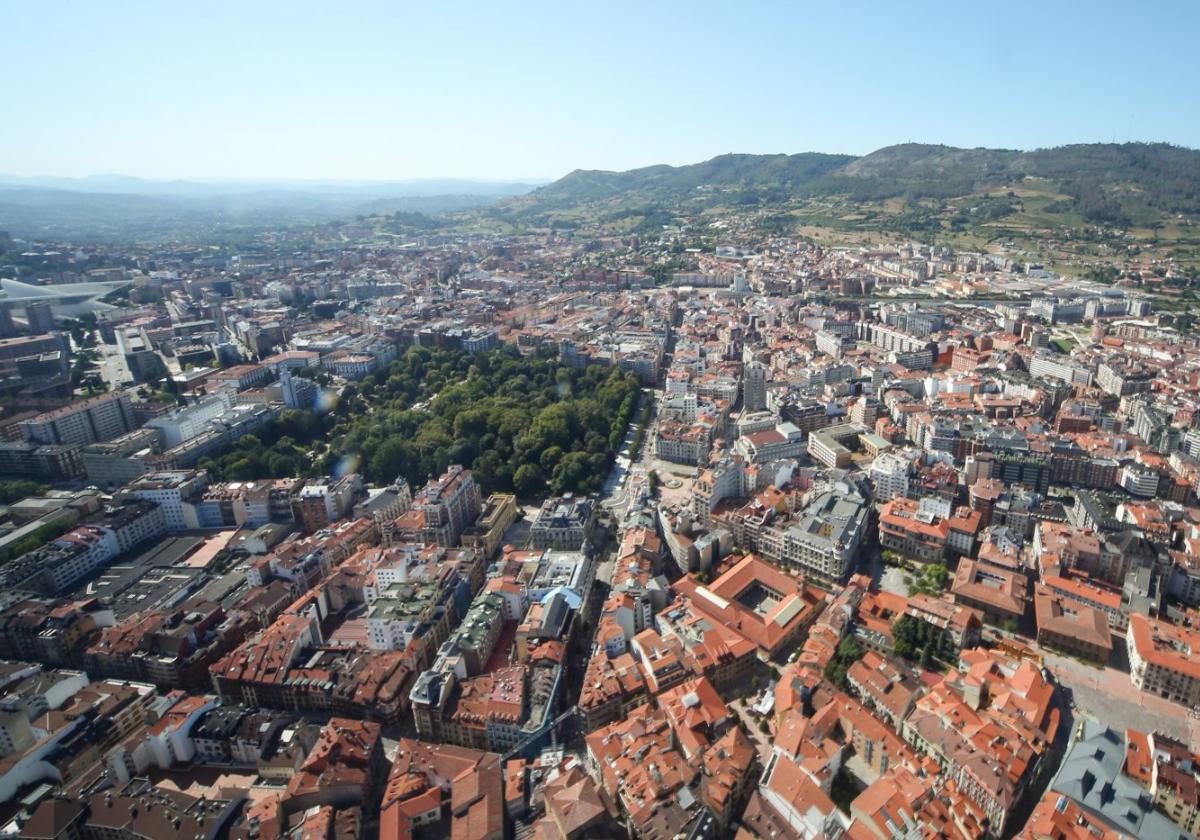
[202,347,640,497]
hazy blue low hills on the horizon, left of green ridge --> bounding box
[0,174,535,240]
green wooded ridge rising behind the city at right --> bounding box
[502,143,1200,223]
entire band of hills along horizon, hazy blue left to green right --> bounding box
[0,143,1200,239]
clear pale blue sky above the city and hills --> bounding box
[9,0,1200,179]
